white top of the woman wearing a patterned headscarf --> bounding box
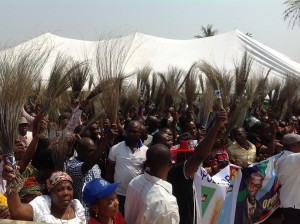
[29,195,86,224]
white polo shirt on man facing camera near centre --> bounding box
[108,141,148,196]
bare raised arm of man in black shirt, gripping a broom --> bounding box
[185,109,227,177]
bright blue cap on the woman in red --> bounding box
[83,178,119,206]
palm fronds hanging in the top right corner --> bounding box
[283,0,300,29]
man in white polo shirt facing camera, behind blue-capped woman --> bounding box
[106,121,148,214]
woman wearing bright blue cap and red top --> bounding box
[83,178,126,224]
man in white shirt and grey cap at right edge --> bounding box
[277,134,300,224]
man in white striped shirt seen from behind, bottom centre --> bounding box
[125,144,179,224]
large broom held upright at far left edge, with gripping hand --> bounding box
[0,46,49,193]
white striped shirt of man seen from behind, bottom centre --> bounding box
[125,173,179,224]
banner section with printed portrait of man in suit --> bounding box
[234,161,280,224]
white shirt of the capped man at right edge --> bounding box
[277,151,300,209]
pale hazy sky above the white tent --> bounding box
[0,0,300,62]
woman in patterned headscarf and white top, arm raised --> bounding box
[3,169,86,224]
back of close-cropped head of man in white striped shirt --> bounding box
[146,144,171,172]
